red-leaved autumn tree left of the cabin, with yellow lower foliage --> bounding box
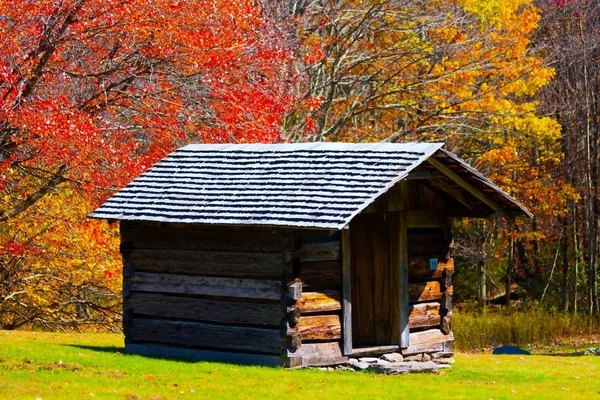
[0,0,295,328]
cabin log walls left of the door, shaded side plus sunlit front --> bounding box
[121,222,346,367]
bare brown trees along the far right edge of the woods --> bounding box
[536,0,600,314]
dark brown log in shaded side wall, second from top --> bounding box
[126,249,284,278]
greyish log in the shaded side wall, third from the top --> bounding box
[129,272,282,301]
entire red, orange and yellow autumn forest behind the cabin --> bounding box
[0,0,600,346]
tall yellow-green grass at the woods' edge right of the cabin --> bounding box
[452,307,600,351]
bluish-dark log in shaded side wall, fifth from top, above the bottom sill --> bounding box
[127,318,282,354]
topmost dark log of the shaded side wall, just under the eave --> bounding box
[121,225,293,253]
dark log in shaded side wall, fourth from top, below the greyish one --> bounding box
[123,292,284,328]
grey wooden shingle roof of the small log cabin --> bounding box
[91,143,527,229]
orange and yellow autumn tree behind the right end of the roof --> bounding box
[284,0,577,306]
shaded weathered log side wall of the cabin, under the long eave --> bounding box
[121,222,300,365]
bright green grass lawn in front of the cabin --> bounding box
[0,331,600,400]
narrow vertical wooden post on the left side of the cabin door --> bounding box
[342,229,352,355]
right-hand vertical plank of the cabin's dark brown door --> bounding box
[372,213,392,345]
